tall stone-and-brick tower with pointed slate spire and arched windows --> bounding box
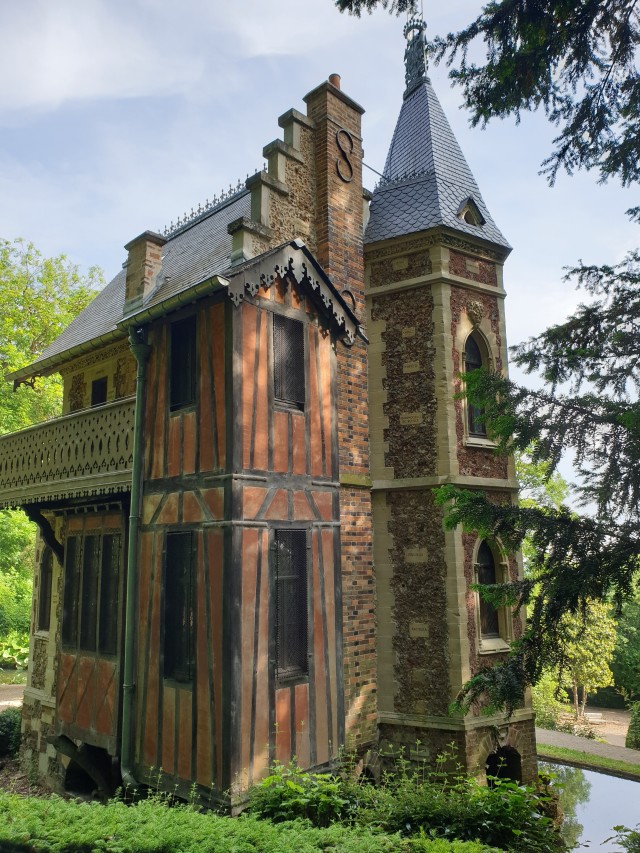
[365,19,536,780]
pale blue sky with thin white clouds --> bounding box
[0,0,638,352]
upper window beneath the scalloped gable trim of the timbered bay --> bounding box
[273,314,305,410]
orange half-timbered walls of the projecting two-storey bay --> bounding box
[135,284,344,792]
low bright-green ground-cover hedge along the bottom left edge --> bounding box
[0,793,504,853]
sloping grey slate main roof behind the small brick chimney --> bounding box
[11,189,251,378]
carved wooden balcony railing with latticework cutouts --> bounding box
[0,397,135,507]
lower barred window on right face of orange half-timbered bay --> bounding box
[274,530,309,679]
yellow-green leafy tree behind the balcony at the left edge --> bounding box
[0,239,103,637]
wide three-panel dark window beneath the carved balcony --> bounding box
[62,533,121,656]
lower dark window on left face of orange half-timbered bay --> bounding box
[163,532,195,682]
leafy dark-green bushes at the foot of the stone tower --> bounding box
[249,756,559,853]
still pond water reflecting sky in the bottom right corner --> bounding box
[540,762,640,853]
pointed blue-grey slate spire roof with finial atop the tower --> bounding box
[365,19,510,250]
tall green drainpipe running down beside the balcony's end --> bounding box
[120,326,151,788]
